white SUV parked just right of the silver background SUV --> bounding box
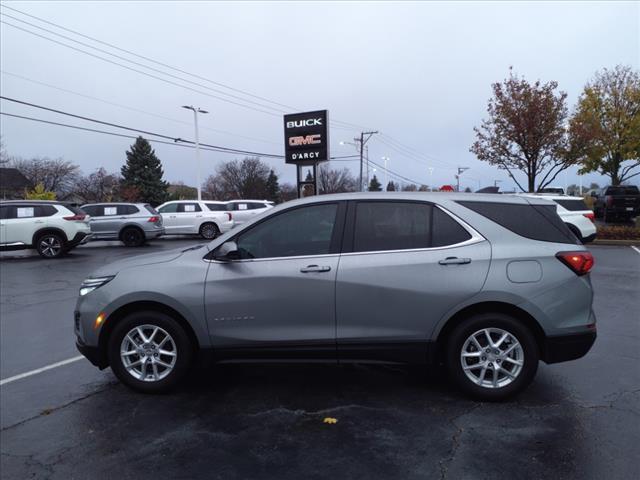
[157,200,234,240]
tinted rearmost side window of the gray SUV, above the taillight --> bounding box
[458,201,577,244]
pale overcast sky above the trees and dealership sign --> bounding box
[0,1,640,189]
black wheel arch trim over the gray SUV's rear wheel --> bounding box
[434,301,546,363]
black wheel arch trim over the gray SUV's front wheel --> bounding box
[98,301,200,368]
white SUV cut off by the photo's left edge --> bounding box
[0,200,91,258]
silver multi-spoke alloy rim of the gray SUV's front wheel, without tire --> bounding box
[120,324,178,382]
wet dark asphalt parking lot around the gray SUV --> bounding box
[0,239,640,479]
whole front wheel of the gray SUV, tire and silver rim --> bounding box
[108,311,193,393]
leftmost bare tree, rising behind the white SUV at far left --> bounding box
[11,157,80,200]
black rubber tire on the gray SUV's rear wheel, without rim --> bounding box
[446,313,540,401]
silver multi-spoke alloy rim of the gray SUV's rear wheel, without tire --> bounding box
[460,328,524,388]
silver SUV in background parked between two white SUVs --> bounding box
[81,203,164,247]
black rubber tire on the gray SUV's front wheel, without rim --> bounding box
[107,311,193,393]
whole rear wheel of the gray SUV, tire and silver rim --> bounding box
[446,313,539,401]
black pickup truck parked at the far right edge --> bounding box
[591,185,640,222]
